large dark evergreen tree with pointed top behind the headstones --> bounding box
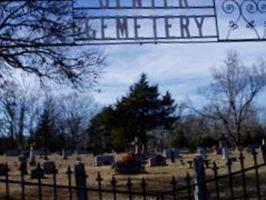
[87,74,176,151]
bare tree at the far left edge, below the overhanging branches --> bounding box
[0,81,39,145]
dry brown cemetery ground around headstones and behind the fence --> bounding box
[0,151,266,200]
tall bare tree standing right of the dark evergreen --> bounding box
[190,52,266,145]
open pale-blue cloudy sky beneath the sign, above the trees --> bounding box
[94,42,266,105]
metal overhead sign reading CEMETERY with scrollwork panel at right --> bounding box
[73,0,266,45]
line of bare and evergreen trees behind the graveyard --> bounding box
[0,52,266,154]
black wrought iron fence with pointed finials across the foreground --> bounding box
[0,151,266,200]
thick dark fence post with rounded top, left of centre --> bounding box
[75,161,88,200]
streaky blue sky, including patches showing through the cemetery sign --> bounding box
[77,0,266,105]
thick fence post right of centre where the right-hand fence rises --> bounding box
[194,156,209,200]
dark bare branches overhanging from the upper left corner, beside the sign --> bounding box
[0,0,104,86]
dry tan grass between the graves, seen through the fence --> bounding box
[0,152,266,200]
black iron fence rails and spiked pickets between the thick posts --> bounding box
[0,151,266,200]
